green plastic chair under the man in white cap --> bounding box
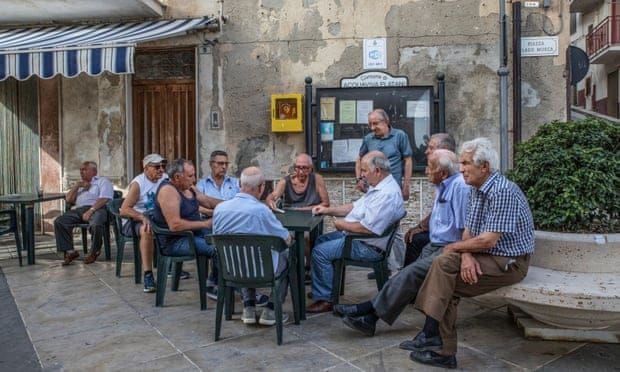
[107,198,142,284]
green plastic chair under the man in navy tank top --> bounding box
[151,223,209,310]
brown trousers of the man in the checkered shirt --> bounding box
[415,252,530,355]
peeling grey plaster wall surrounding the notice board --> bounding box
[209,0,569,177]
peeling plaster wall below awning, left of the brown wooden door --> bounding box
[61,74,127,189]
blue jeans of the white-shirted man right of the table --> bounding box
[312,231,380,301]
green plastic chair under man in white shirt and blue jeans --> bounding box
[332,219,400,304]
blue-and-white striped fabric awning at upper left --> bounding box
[0,17,214,81]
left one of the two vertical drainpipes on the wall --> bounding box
[497,0,508,172]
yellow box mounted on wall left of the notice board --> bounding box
[271,94,303,132]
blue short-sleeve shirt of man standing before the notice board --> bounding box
[359,128,413,185]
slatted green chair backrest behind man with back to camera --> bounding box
[212,234,287,283]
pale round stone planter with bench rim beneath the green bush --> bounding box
[494,231,620,329]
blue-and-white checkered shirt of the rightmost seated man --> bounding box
[465,172,534,257]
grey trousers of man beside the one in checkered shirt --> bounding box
[372,243,443,325]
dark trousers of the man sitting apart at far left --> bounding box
[54,205,108,252]
